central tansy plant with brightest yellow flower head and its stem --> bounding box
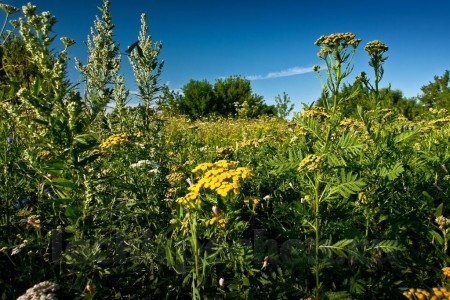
[174,160,252,299]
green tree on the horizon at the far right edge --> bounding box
[419,70,450,109]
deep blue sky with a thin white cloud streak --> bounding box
[3,0,450,110]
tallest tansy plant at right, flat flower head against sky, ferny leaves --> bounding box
[284,32,395,299]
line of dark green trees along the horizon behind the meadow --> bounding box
[0,23,450,120]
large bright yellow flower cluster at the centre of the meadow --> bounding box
[177,160,252,208]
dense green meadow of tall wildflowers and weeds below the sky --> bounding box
[0,0,450,299]
